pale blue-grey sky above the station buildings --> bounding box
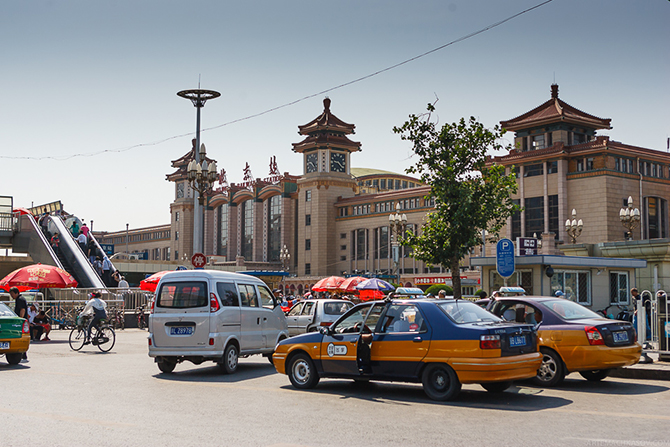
[0,0,670,231]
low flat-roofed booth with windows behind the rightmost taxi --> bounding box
[470,255,647,310]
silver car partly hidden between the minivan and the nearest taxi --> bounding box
[286,299,354,336]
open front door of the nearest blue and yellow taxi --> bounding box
[321,303,383,376]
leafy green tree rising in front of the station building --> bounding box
[393,104,520,298]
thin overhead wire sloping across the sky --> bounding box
[0,0,554,161]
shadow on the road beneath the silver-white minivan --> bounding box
[154,359,277,383]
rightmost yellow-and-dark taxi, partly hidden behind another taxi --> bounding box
[489,296,642,386]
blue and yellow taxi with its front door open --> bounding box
[273,299,542,400]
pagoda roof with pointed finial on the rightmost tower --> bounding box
[500,84,612,132]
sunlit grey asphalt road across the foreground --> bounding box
[0,329,670,447]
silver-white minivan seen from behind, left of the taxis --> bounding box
[149,270,288,374]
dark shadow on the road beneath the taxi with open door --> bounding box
[282,379,572,412]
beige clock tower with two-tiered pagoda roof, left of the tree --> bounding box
[293,98,361,276]
